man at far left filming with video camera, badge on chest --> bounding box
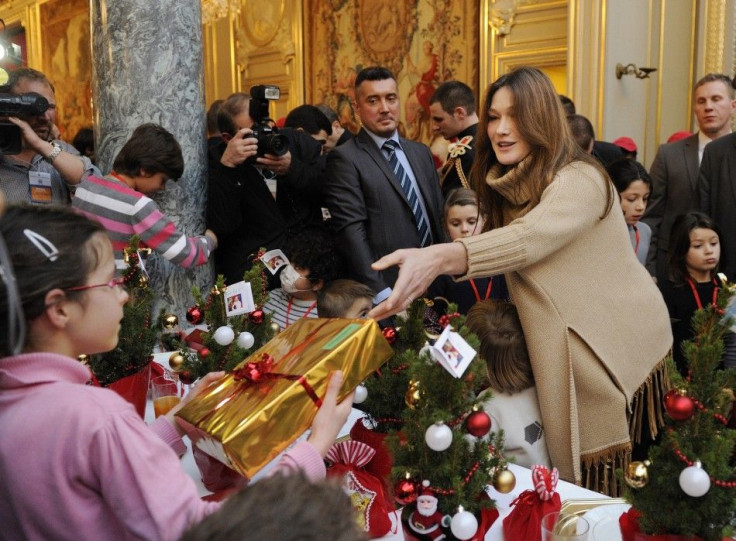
[0,68,100,204]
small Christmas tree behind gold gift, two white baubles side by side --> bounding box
[169,253,279,383]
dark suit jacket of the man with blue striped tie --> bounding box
[325,129,444,293]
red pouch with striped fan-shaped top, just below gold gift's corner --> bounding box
[326,440,398,537]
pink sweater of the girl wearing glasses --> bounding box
[0,353,325,540]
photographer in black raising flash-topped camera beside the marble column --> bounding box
[207,86,322,283]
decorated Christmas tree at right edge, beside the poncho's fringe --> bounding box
[624,287,736,541]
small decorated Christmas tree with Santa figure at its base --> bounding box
[365,299,506,539]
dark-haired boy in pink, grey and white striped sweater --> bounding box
[72,124,217,269]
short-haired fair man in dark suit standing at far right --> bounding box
[642,73,736,280]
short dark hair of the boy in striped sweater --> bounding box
[112,124,184,180]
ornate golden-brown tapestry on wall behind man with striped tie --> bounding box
[304,0,478,145]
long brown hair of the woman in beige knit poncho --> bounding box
[470,66,613,231]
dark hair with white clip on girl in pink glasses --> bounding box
[0,205,104,356]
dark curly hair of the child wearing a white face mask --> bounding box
[284,227,344,284]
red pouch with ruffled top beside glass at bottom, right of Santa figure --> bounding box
[503,466,562,541]
